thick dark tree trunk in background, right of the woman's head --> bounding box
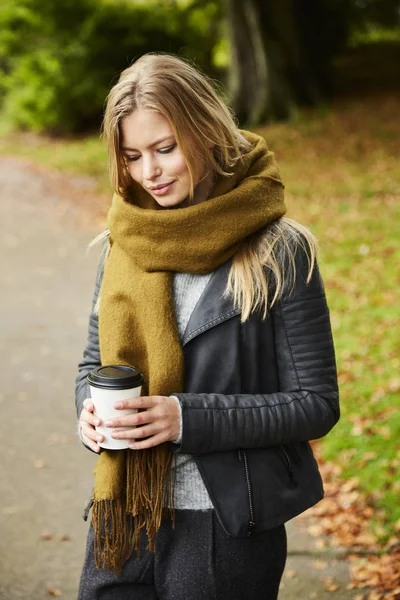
[226,0,336,126]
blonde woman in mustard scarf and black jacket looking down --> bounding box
[76,54,339,600]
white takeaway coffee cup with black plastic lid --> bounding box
[87,365,144,450]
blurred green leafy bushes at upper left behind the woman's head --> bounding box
[0,0,219,133]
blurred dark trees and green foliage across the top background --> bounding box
[0,0,400,134]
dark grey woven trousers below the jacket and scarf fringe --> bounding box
[79,510,287,600]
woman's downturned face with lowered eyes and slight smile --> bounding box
[121,108,209,208]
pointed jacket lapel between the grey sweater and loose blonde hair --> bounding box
[182,260,240,346]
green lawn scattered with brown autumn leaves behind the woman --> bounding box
[0,95,400,541]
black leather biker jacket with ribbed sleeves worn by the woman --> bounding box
[76,244,339,537]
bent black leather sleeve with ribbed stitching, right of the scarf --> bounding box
[174,246,340,454]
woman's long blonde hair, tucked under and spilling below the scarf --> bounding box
[94,53,316,321]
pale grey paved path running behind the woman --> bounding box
[0,157,355,600]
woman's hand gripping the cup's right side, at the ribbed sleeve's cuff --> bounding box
[105,396,180,450]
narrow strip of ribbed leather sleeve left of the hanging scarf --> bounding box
[75,254,103,419]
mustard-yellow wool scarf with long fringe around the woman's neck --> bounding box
[92,131,285,573]
